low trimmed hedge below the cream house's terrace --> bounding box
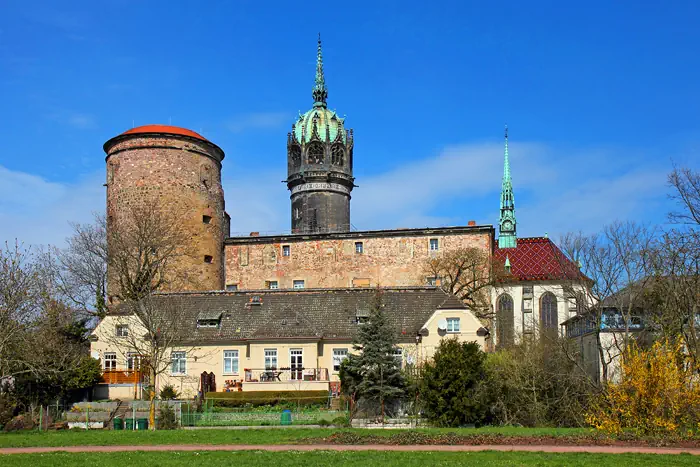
[205,391,328,407]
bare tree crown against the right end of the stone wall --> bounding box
[422,247,504,320]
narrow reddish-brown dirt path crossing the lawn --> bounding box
[0,444,700,456]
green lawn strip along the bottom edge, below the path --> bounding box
[0,451,698,467]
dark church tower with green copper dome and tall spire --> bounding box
[286,34,355,233]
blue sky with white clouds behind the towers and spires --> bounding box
[0,0,700,244]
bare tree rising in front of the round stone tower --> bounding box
[106,201,202,429]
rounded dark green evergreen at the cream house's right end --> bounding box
[421,339,487,426]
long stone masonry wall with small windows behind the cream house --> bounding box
[225,227,493,290]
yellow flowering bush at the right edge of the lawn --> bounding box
[586,341,700,436]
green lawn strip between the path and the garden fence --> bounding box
[0,427,593,447]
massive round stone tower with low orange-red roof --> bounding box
[104,125,229,300]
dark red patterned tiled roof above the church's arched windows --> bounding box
[494,237,585,281]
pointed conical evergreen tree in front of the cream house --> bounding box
[340,291,406,419]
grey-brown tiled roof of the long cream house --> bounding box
[113,287,466,344]
